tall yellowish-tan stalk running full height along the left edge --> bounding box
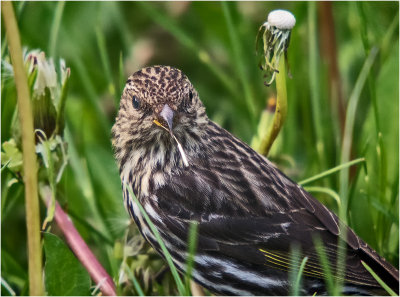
[1,2,43,295]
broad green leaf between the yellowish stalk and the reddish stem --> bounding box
[44,233,91,296]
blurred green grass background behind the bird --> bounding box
[1,1,399,295]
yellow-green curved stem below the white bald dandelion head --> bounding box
[260,57,287,156]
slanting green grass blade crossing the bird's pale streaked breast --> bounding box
[124,184,185,296]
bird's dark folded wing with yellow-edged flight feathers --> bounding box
[153,167,376,286]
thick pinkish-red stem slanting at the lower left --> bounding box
[54,201,117,296]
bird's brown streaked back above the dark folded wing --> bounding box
[153,126,360,245]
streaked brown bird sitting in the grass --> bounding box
[112,65,399,295]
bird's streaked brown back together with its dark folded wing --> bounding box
[154,126,396,285]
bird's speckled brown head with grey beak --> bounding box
[112,66,208,170]
